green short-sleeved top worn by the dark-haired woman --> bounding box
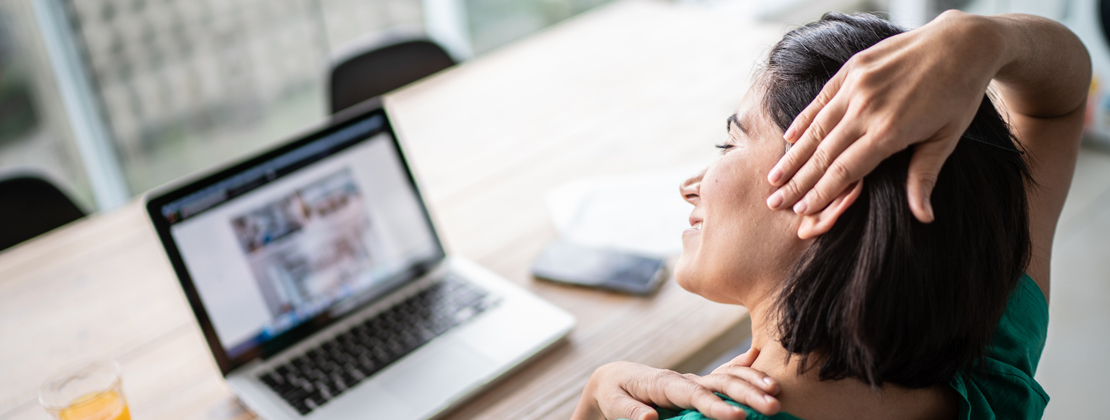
[658,273,1048,420]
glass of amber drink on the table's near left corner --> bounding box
[39,360,131,420]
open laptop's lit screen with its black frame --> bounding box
[149,111,443,370]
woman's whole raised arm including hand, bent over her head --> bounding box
[768,11,1090,297]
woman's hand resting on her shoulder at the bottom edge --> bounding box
[572,350,779,420]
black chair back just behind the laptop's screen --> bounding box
[329,38,455,114]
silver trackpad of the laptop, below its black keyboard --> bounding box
[384,339,497,409]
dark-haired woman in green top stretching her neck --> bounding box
[575,12,1090,419]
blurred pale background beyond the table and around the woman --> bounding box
[0,0,1110,419]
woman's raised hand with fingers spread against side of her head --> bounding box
[767,11,1003,222]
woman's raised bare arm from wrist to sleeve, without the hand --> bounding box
[986,14,1091,298]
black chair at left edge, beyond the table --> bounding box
[0,174,84,251]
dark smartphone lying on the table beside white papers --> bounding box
[532,239,667,294]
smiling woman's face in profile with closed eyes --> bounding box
[675,87,806,307]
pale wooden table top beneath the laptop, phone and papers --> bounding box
[0,1,783,419]
